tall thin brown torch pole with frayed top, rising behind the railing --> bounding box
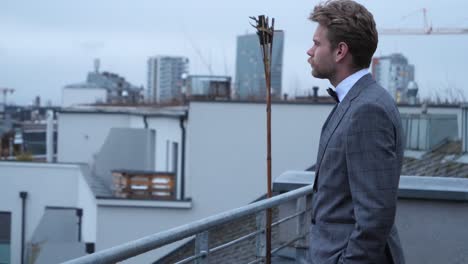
[251,15,275,264]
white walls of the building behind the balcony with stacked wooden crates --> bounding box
[58,112,182,198]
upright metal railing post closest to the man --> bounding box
[295,196,308,263]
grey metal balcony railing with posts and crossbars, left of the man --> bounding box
[65,185,312,264]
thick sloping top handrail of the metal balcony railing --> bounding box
[61,185,312,264]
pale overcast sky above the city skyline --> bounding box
[0,0,468,104]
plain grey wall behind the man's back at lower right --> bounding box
[395,199,468,264]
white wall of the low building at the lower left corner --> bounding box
[0,162,96,263]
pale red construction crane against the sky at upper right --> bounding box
[378,8,468,35]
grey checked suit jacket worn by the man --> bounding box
[309,74,404,264]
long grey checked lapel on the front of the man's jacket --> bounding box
[315,74,374,174]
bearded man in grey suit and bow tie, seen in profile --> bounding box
[307,0,404,264]
